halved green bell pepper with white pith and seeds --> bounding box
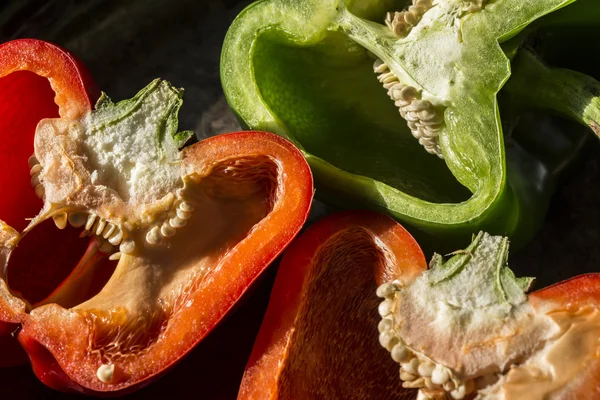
[221,0,587,246]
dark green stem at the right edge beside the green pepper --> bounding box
[504,50,600,137]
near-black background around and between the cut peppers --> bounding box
[0,0,600,399]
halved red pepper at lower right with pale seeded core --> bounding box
[238,212,600,400]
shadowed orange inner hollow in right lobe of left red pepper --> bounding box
[74,156,279,368]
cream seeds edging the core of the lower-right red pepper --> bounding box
[377,282,476,400]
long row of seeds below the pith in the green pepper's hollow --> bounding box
[373,59,444,158]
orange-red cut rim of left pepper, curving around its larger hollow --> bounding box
[18,132,313,396]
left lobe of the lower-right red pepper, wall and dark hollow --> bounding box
[238,211,427,400]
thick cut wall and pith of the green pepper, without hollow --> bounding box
[221,0,574,245]
